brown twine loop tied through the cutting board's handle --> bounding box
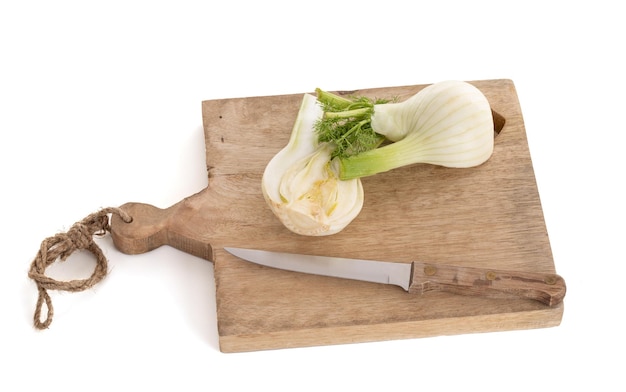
[28,207,132,329]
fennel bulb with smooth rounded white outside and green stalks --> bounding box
[317,81,494,180]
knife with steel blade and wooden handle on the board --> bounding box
[224,247,566,306]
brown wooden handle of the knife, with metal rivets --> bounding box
[409,262,566,306]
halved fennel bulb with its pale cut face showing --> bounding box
[262,94,364,236]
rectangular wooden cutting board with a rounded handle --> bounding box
[112,80,563,352]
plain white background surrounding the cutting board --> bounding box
[0,0,626,391]
